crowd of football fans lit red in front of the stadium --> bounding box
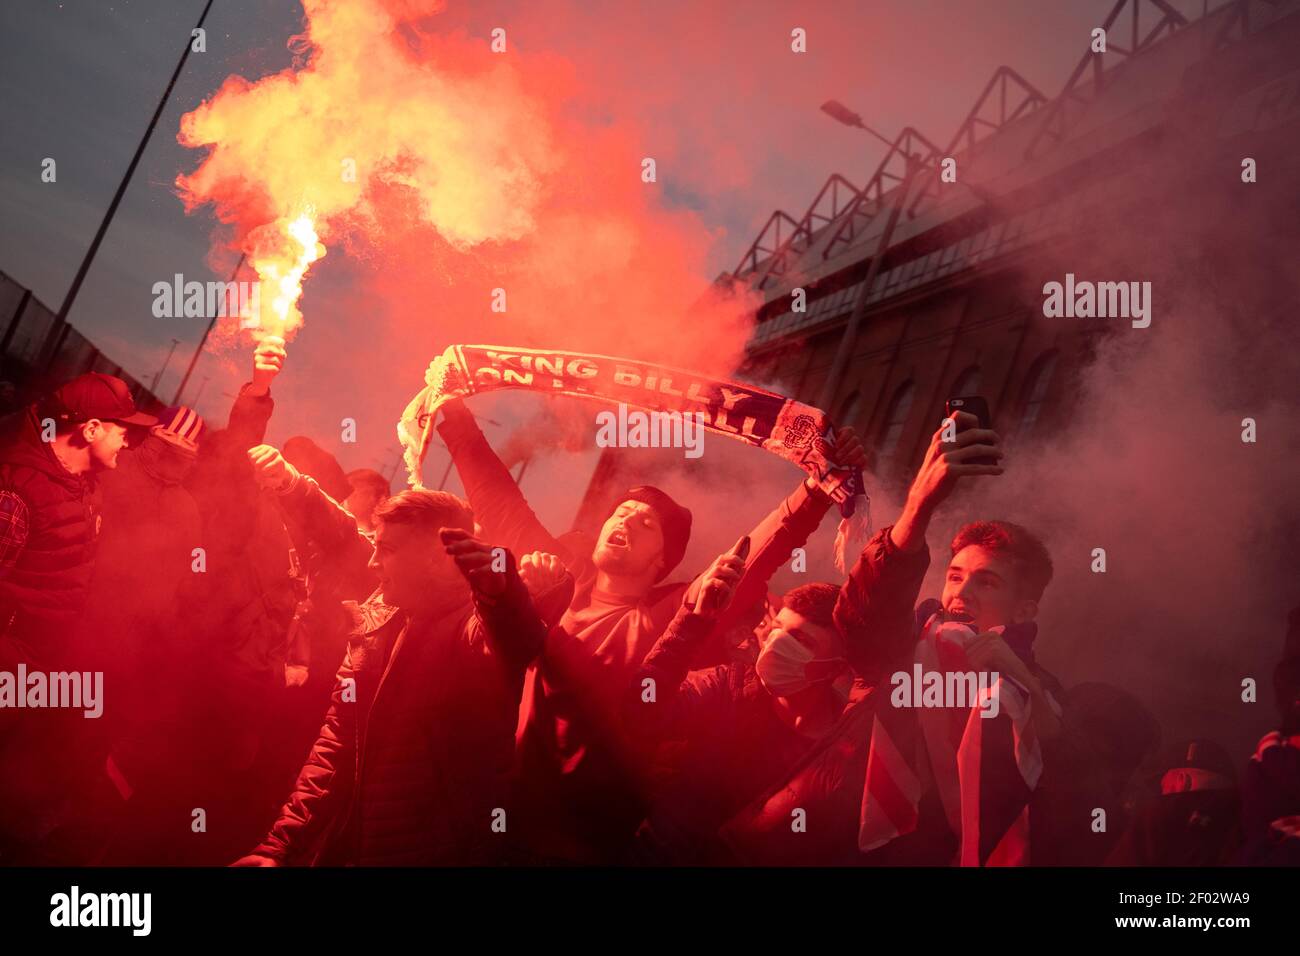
[0,338,1300,866]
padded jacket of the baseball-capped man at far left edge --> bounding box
[0,406,100,670]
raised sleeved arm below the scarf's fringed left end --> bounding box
[438,401,577,567]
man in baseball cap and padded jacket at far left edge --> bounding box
[0,372,157,862]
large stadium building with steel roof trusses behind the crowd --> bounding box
[722,0,1300,485]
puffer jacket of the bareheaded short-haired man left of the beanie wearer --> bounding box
[254,558,545,866]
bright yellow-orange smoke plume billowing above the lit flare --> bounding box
[178,0,748,377]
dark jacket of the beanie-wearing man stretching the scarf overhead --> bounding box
[438,403,831,862]
